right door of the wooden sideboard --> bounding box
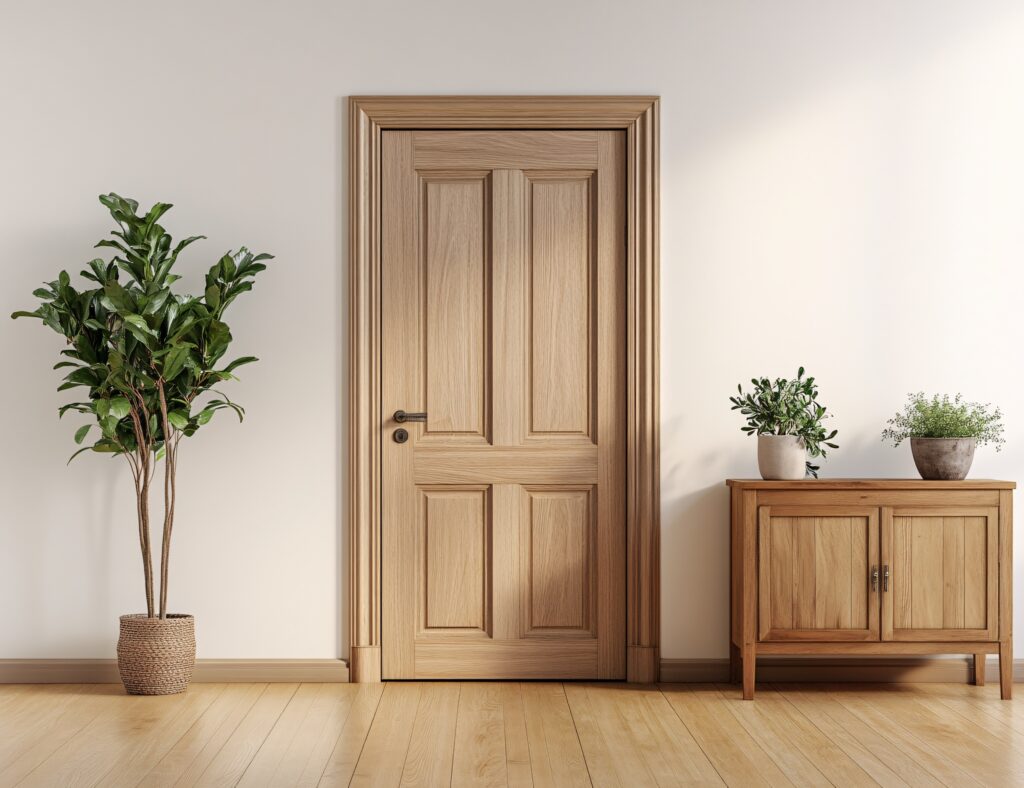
[882,508,998,641]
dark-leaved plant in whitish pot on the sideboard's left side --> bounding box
[729,366,839,479]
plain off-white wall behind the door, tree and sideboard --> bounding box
[0,0,1024,658]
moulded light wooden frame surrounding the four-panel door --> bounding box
[347,96,660,683]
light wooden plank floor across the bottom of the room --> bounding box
[0,683,1024,788]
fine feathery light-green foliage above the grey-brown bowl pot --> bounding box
[882,392,1005,451]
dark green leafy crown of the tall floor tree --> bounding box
[11,193,271,462]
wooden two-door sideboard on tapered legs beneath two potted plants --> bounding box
[727,479,1017,700]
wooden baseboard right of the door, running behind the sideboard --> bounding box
[662,657,1024,684]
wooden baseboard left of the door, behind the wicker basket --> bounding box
[0,659,348,684]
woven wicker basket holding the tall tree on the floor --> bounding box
[118,613,196,695]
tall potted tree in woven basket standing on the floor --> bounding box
[11,193,271,695]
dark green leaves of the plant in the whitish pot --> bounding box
[729,366,839,478]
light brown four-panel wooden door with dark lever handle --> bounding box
[381,131,626,678]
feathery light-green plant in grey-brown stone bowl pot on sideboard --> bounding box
[882,392,1004,479]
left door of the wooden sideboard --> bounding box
[758,506,880,641]
